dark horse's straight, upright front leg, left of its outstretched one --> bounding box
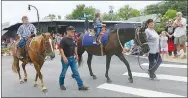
[105,55,112,83]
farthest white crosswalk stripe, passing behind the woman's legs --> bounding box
[141,63,187,68]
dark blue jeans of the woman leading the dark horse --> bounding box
[148,53,162,73]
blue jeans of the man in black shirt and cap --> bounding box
[59,57,83,87]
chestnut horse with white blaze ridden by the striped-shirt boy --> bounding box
[12,33,55,92]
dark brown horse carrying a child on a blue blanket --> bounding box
[75,27,149,83]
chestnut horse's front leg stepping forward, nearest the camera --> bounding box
[33,62,48,92]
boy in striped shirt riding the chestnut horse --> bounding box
[17,16,36,59]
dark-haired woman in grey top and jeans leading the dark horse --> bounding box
[145,19,162,80]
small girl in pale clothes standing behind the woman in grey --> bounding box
[160,31,168,59]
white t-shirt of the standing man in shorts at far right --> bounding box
[174,18,187,37]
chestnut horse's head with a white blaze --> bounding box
[42,33,55,59]
